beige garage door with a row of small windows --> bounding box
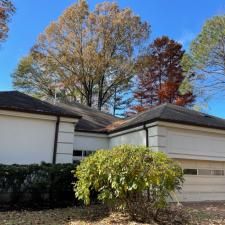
[177,160,225,201]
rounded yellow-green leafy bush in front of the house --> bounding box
[74,145,183,220]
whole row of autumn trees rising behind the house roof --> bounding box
[4,0,225,115]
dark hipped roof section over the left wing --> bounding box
[0,91,80,119]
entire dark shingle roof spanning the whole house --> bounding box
[0,91,225,133]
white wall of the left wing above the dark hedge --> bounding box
[0,110,77,164]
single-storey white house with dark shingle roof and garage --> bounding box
[0,91,225,201]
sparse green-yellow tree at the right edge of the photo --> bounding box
[188,15,225,94]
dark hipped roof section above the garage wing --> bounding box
[111,103,225,133]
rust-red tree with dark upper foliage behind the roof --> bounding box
[132,36,195,112]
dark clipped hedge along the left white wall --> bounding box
[0,163,79,208]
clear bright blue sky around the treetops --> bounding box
[0,0,225,118]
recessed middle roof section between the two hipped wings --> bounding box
[54,102,120,133]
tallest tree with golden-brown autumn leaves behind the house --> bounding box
[14,0,149,110]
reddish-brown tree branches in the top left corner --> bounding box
[0,0,15,45]
